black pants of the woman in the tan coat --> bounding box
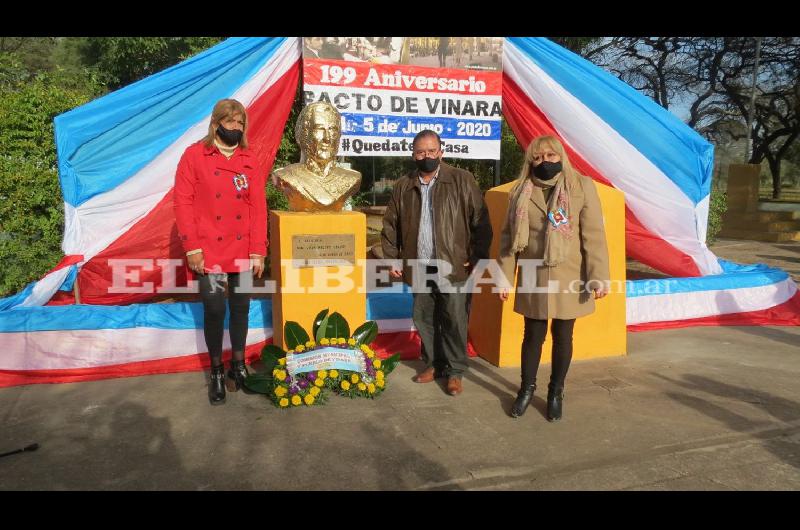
[521,317,575,389]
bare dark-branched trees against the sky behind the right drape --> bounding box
[584,37,800,198]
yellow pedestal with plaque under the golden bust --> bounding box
[269,211,367,347]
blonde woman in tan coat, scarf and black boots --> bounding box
[500,136,610,421]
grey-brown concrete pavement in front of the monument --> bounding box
[0,327,800,490]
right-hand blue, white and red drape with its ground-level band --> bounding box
[503,38,800,329]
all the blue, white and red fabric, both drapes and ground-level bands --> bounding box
[0,38,800,386]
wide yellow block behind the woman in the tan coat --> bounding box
[469,182,627,366]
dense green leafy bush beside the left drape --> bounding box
[0,63,104,296]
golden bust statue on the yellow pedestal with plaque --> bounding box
[273,101,361,212]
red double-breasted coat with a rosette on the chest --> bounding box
[174,142,267,272]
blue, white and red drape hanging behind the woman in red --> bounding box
[2,38,301,309]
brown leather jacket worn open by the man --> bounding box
[381,162,492,285]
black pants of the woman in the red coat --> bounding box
[199,272,250,366]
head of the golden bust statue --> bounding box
[294,101,342,167]
